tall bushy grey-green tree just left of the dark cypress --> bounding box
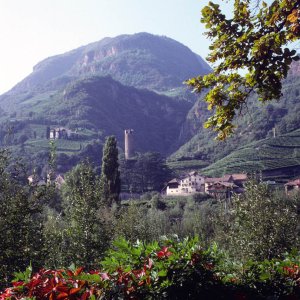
[57,162,109,266]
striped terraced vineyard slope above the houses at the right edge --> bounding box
[201,130,300,176]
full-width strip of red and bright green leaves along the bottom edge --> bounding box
[0,238,300,300]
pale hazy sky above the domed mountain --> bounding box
[0,0,227,94]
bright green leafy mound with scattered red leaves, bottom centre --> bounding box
[101,237,225,299]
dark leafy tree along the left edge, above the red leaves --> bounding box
[0,150,45,285]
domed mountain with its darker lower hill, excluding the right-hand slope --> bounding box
[0,33,211,172]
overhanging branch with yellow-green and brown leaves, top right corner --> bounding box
[187,0,300,140]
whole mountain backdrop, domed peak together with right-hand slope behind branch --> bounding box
[0,33,300,179]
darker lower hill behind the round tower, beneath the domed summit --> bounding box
[0,77,191,168]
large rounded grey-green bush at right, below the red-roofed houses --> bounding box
[214,181,299,260]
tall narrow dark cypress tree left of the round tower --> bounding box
[100,136,121,206]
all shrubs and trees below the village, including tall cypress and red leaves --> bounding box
[0,137,300,299]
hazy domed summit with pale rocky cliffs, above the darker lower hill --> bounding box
[0,33,211,111]
